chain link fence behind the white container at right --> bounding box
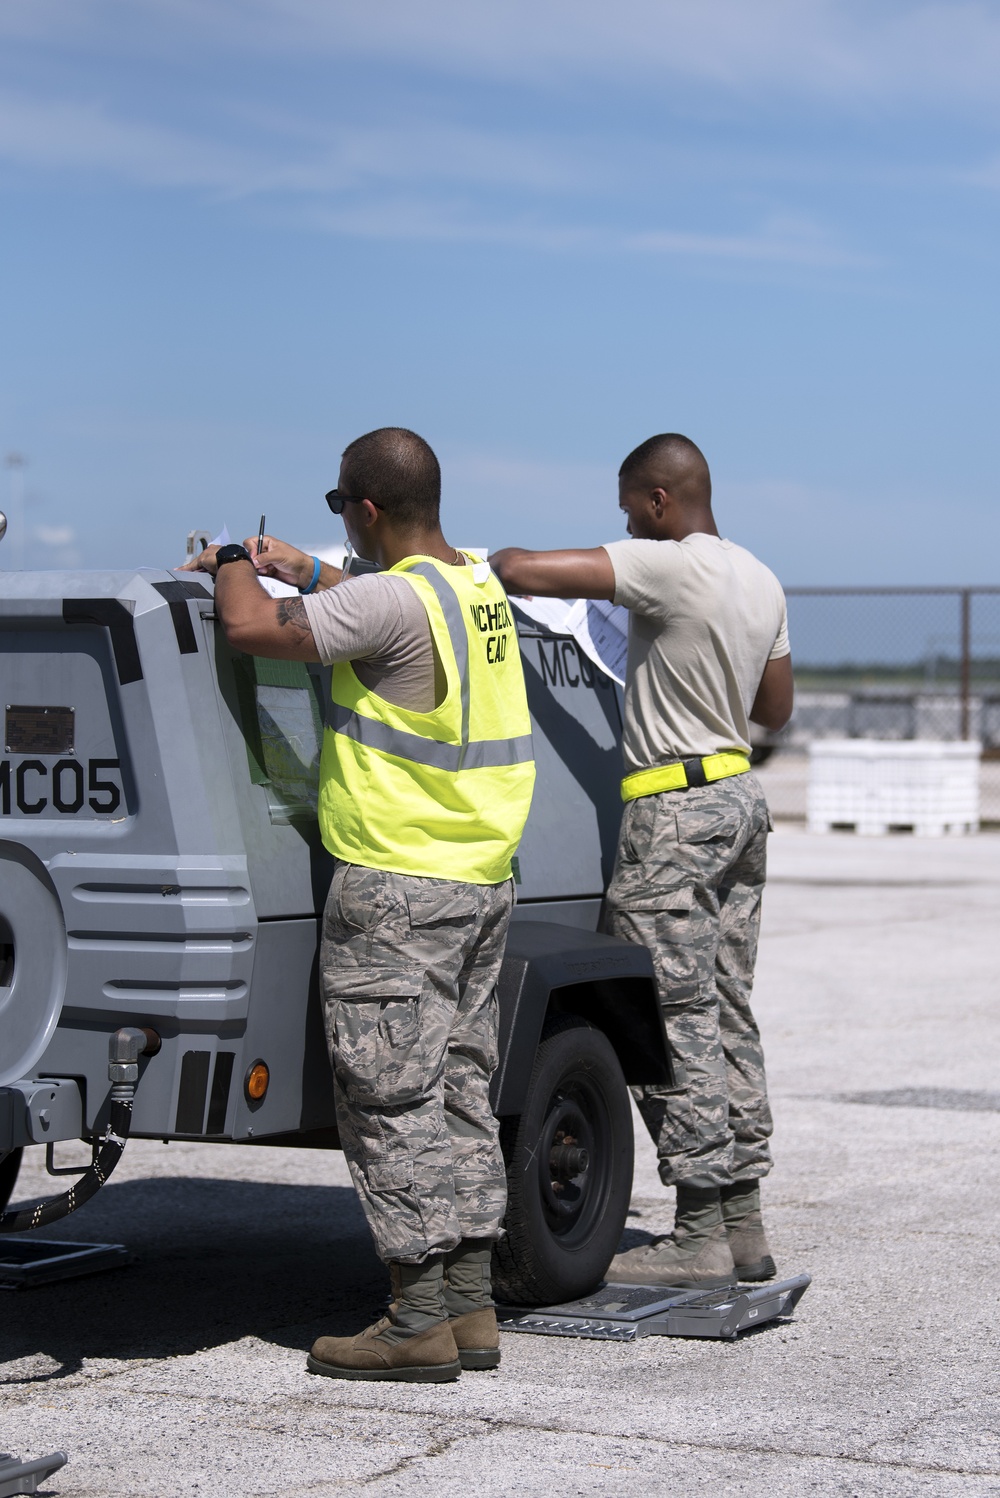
[760,587,1000,827]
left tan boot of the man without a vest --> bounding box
[608,1182,737,1290]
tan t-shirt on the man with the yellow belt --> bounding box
[605,532,789,773]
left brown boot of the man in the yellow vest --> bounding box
[305,1255,461,1384]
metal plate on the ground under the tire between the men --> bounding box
[497,1275,810,1342]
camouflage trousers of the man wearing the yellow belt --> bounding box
[605,774,771,1186]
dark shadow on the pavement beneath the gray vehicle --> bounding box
[0,1176,388,1384]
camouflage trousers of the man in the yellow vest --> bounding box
[320,863,513,1263]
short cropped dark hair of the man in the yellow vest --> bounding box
[341,427,442,527]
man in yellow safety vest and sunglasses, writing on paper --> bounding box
[183,427,534,1383]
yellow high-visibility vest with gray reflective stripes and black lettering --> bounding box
[319,556,534,884]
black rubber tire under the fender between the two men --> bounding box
[493,1014,635,1305]
